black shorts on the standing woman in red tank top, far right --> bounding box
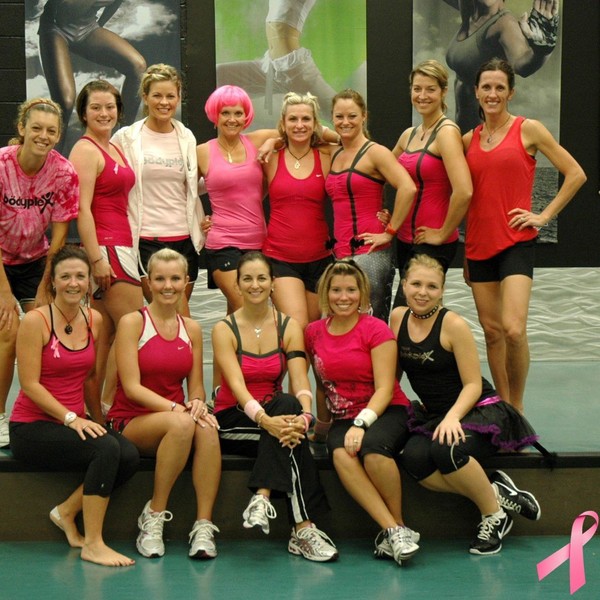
[467,240,535,283]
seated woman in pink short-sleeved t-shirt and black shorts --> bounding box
[305,260,420,564]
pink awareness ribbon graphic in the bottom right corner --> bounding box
[537,510,598,594]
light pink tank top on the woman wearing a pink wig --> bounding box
[204,135,267,250]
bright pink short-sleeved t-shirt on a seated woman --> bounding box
[304,315,409,419]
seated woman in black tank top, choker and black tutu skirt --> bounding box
[391,254,541,554]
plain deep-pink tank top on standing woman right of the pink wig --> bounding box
[263,149,331,263]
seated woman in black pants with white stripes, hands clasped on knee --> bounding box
[212,251,338,562]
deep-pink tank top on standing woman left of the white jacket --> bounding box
[81,135,135,247]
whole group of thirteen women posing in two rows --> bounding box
[0,52,585,566]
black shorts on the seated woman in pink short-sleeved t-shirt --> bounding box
[327,405,410,459]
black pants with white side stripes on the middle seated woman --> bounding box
[215,393,327,525]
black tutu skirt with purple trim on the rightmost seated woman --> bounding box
[408,396,539,451]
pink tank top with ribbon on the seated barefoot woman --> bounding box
[10,307,96,423]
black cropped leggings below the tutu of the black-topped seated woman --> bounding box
[401,430,498,481]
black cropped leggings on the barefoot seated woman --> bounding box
[10,421,140,498]
